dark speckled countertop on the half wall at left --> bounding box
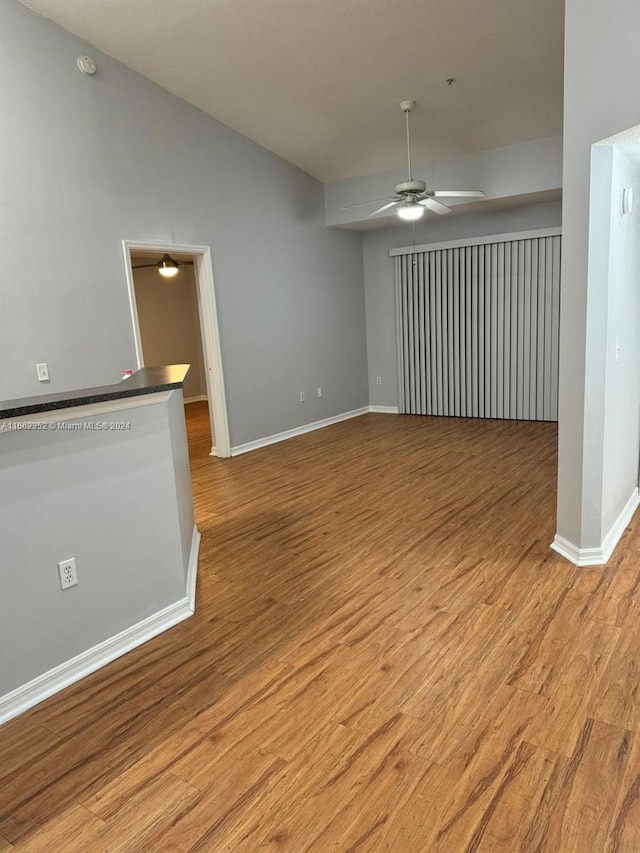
[0,364,191,418]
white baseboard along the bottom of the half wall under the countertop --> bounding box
[0,526,200,725]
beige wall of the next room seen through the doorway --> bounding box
[133,259,207,400]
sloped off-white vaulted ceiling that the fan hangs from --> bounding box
[20,0,564,181]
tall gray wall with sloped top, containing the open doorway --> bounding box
[0,0,368,444]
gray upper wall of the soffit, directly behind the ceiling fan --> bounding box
[324,134,562,229]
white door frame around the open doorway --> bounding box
[122,240,231,457]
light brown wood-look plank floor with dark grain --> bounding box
[0,404,640,853]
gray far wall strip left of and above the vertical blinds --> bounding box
[363,202,562,406]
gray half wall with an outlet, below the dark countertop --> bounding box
[0,391,194,704]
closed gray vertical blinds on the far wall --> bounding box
[394,235,561,421]
